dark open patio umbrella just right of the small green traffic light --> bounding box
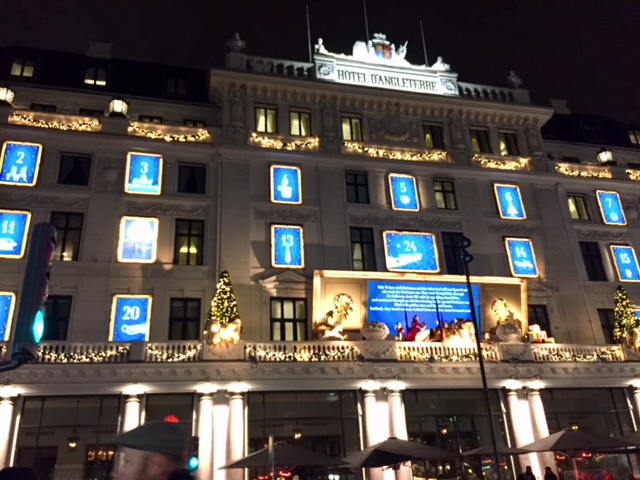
[220,443,346,468]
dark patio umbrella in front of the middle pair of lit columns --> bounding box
[343,437,458,468]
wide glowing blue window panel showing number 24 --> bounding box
[382,231,440,273]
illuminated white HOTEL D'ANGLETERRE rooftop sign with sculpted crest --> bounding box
[314,33,458,96]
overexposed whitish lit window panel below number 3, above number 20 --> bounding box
[118,217,160,263]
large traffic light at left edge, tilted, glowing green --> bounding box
[11,223,56,363]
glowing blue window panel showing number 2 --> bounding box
[0,142,42,187]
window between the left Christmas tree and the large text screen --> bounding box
[271,298,307,342]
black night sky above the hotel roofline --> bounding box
[0,0,640,124]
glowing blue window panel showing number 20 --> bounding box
[109,295,152,342]
